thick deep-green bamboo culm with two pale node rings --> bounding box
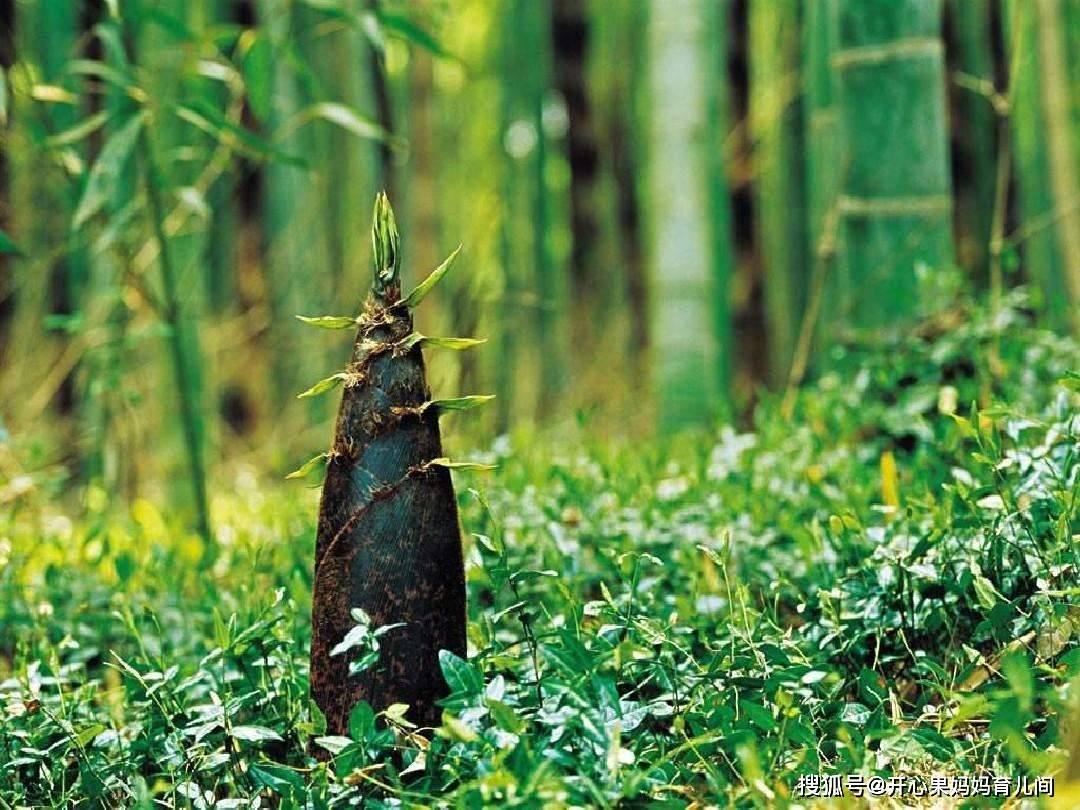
[831,0,953,326]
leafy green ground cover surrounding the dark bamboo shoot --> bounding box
[0,295,1080,808]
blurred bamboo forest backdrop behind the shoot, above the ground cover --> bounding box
[0,0,1080,535]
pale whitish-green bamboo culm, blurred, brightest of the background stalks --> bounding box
[647,0,728,432]
